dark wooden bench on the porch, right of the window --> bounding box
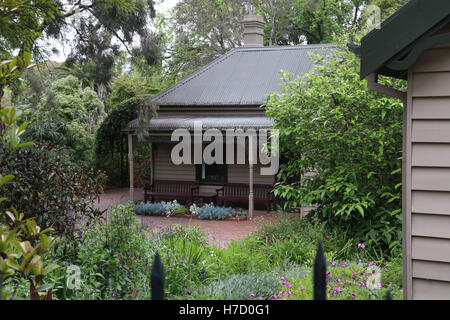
[216,183,273,211]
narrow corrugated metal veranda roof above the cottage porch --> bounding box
[127,115,273,131]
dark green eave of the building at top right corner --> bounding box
[360,0,450,79]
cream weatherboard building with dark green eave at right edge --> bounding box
[359,0,450,299]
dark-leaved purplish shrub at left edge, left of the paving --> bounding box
[0,141,103,239]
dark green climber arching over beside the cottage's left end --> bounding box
[95,96,155,186]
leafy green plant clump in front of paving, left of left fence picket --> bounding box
[73,203,150,299]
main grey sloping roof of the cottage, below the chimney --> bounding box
[150,44,333,106]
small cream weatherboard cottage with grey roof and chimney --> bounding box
[127,15,331,217]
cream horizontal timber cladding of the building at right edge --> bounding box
[406,47,450,299]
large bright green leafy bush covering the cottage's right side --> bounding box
[267,40,403,252]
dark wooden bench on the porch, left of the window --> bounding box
[144,180,199,204]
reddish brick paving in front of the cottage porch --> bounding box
[96,188,271,248]
